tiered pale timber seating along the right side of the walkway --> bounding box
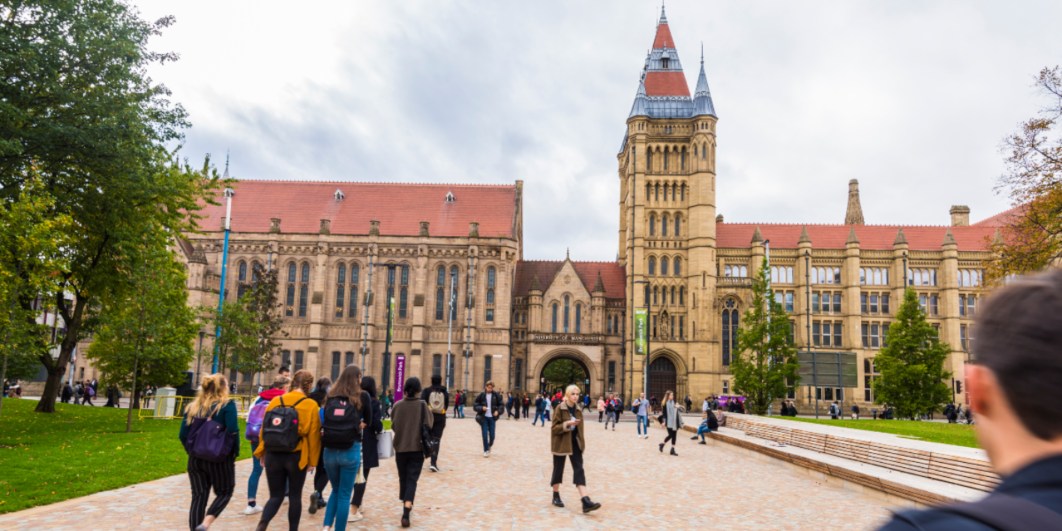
[685,413,999,504]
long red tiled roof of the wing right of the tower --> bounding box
[716,223,995,251]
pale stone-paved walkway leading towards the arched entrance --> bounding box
[0,415,889,531]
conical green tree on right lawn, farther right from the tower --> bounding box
[874,289,952,418]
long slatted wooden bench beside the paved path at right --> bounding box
[719,414,999,503]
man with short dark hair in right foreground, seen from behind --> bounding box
[880,270,1062,531]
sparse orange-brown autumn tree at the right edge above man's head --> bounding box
[988,66,1062,280]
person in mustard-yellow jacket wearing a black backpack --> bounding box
[255,370,321,531]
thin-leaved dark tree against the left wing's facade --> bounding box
[211,263,287,382]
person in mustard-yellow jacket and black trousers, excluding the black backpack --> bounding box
[255,371,321,531]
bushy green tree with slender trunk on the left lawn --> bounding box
[86,232,199,432]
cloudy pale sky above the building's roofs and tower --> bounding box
[132,0,1062,260]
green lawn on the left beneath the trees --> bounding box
[0,399,251,514]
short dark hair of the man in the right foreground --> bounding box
[973,270,1062,441]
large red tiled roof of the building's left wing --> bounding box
[200,181,516,238]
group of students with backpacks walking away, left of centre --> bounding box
[178,365,433,531]
